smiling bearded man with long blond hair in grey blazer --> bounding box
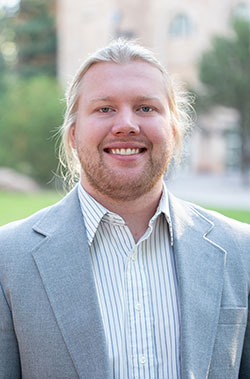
[0,41,250,379]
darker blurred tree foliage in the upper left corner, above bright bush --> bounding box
[0,0,57,78]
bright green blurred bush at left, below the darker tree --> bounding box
[0,76,63,184]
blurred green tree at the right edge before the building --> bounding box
[200,18,250,182]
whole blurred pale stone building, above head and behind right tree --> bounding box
[57,0,250,172]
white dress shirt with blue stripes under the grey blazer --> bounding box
[78,184,180,379]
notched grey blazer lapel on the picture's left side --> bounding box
[33,189,110,379]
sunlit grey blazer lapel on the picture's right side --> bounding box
[170,195,226,379]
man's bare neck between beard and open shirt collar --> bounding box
[82,181,162,242]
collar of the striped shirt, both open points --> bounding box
[78,183,173,246]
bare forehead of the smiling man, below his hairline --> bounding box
[80,61,166,96]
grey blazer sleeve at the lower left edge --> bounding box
[0,283,21,379]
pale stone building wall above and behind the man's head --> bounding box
[57,0,250,84]
